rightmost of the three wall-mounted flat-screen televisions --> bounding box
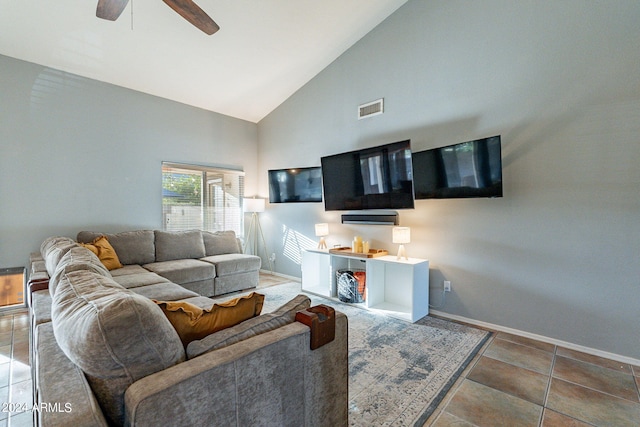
[413,135,502,199]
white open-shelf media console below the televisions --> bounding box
[302,249,429,322]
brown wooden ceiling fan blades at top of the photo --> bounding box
[96,0,220,35]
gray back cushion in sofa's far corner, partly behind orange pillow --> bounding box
[77,230,156,265]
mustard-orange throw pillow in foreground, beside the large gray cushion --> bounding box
[154,292,264,347]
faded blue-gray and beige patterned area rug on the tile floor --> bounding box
[216,282,490,426]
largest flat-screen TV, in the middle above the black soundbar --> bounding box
[320,140,414,211]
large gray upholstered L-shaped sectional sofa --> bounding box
[29,232,348,427]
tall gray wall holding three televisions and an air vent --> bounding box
[258,0,640,359]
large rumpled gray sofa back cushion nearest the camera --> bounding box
[51,271,185,425]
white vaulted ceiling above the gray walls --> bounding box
[0,0,407,122]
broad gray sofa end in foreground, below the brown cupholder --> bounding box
[125,312,349,426]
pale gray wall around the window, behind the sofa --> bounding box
[0,56,257,267]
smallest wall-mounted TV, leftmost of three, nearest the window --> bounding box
[269,167,322,203]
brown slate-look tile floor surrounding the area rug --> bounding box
[5,274,640,427]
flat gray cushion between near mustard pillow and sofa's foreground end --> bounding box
[187,294,311,359]
